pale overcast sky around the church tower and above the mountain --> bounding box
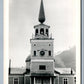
[9,0,76,67]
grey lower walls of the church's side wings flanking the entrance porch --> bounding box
[8,74,75,84]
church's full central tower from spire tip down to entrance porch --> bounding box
[30,0,54,84]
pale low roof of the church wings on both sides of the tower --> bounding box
[10,68,75,75]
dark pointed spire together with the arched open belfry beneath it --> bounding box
[33,0,50,39]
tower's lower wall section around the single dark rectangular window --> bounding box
[30,60,54,74]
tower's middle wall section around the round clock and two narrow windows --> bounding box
[31,40,53,58]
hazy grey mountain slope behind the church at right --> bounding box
[55,46,76,71]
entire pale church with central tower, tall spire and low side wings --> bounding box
[8,0,76,84]
